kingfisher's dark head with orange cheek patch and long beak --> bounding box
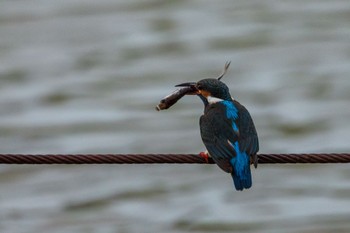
[176,78,232,100]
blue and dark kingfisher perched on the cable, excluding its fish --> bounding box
[176,75,259,191]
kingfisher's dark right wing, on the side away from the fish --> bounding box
[234,101,259,159]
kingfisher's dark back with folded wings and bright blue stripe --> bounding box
[200,100,259,179]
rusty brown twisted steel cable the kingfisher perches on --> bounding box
[0,153,350,164]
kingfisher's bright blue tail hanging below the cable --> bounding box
[230,153,252,191]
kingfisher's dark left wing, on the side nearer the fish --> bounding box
[200,103,238,173]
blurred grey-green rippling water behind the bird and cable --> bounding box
[0,0,350,233]
